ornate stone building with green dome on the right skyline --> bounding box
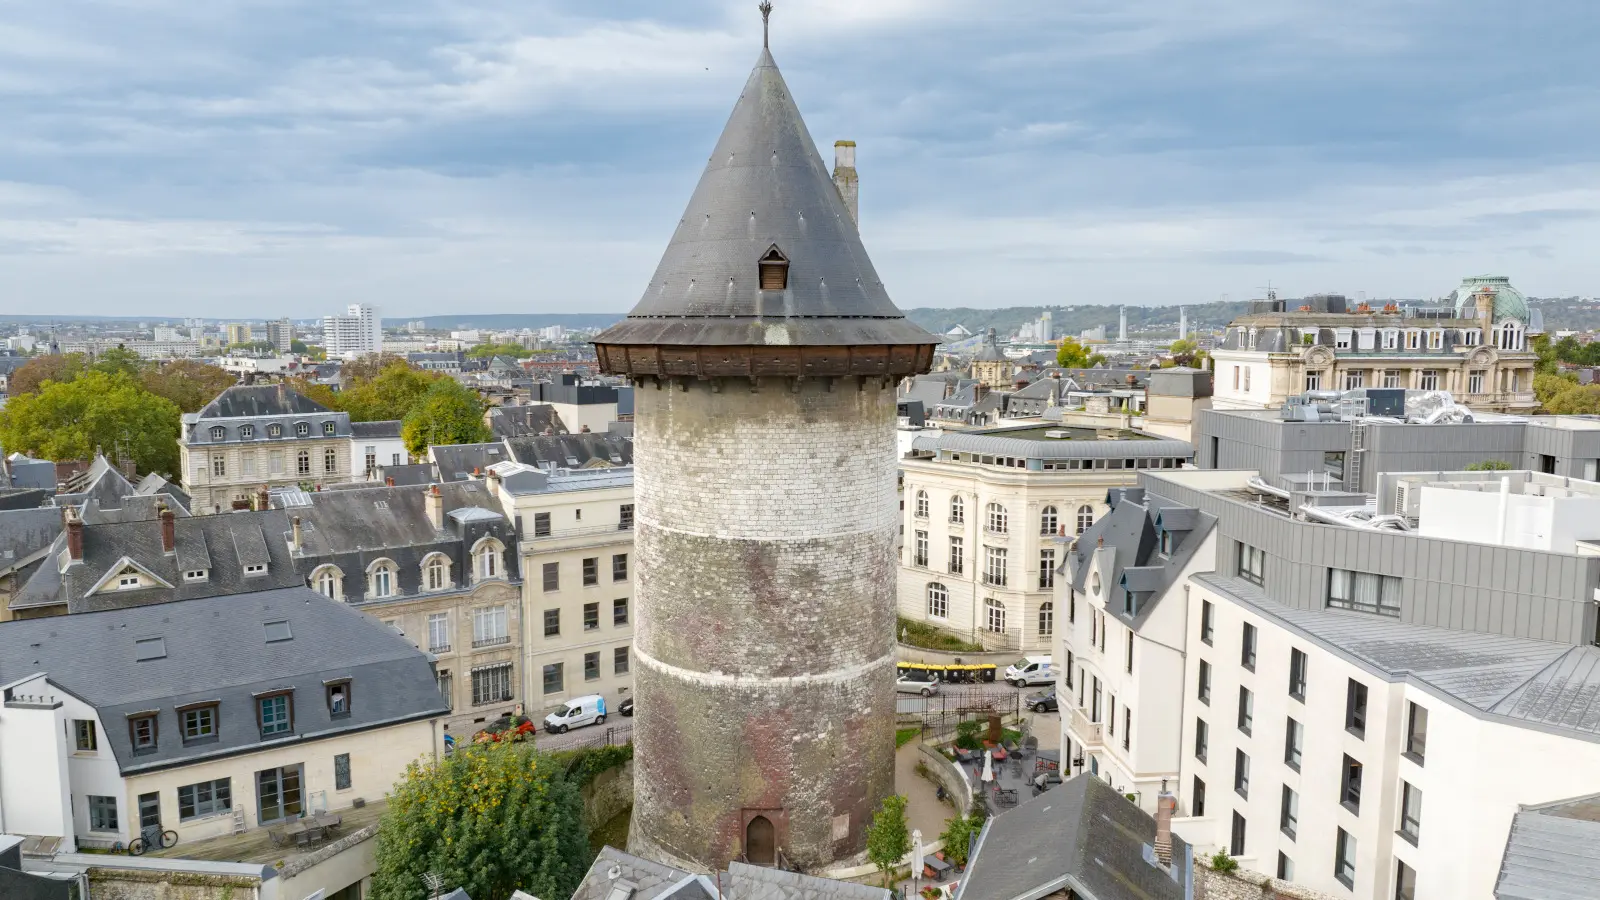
[1211,275,1544,413]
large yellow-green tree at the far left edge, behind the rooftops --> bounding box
[0,372,181,477]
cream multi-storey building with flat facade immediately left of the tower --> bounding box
[483,461,637,709]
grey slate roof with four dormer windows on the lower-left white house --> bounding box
[0,588,448,775]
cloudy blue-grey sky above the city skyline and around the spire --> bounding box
[0,0,1600,317]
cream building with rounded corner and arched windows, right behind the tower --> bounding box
[896,426,1192,650]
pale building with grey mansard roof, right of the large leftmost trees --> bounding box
[178,384,352,512]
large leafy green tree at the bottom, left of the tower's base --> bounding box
[373,741,590,900]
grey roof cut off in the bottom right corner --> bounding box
[1494,794,1600,900]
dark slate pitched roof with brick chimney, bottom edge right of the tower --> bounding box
[955,773,1192,900]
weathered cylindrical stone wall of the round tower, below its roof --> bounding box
[630,380,898,871]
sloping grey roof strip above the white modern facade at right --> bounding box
[1194,575,1600,741]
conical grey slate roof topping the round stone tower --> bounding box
[595,50,938,372]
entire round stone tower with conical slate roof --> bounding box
[594,22,938,871]
